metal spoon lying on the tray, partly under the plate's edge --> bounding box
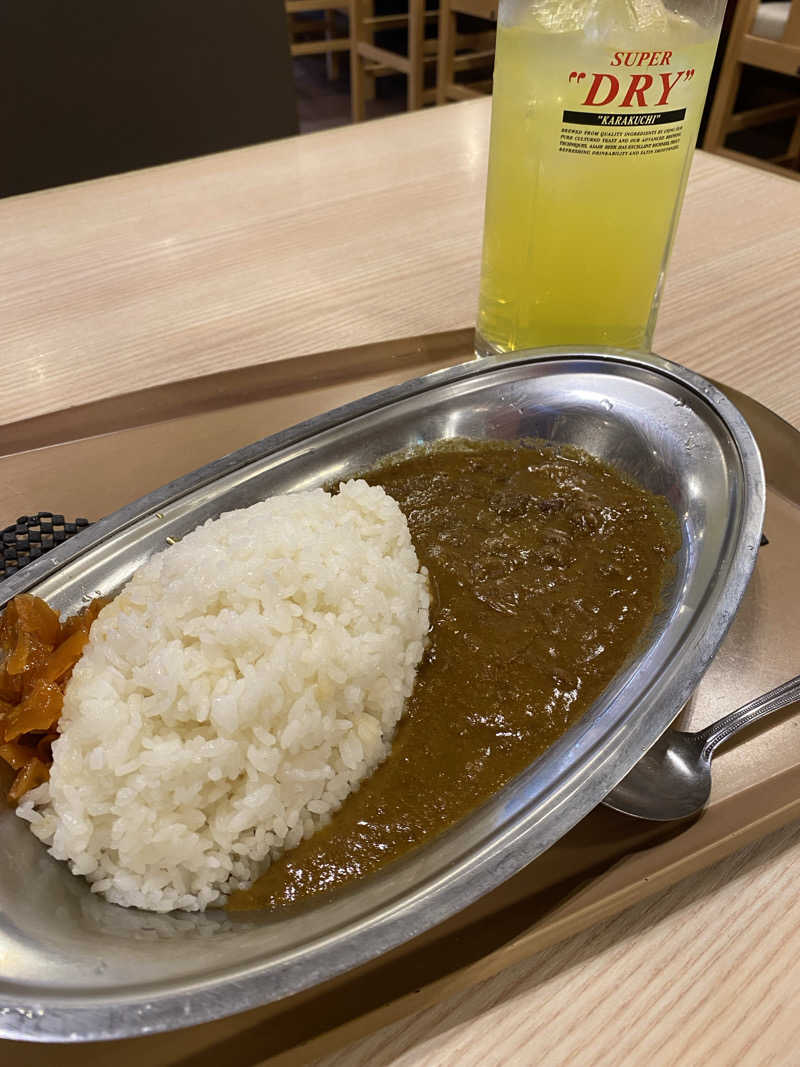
[604,675,800,823]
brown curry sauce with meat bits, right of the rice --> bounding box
[228,440,681,909]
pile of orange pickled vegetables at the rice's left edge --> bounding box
[0,593,108,803]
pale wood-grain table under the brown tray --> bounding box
[0,100,800,1067]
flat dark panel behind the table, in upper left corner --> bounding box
[0,0,298,196]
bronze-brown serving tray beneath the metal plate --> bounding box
[0,332,800,1065]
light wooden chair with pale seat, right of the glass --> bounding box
[703,0,800,175]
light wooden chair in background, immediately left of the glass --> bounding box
[436,0,497,103]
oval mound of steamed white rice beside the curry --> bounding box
[17,481,429,911]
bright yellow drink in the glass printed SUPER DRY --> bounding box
[478,6,717,353]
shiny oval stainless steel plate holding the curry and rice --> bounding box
[0,350,765,1040]
